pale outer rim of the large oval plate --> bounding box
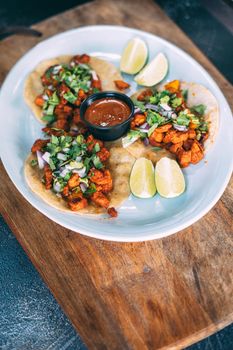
[0,25,233,243]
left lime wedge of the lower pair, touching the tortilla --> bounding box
[129,158,156,198]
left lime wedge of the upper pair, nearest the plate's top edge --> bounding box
[120,37,148,74]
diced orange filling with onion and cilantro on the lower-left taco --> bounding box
[26,135,117,217]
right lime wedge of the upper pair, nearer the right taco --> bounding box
[134,52,168,86]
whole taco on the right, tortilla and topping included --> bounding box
[123,80,219,167]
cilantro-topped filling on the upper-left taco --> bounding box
[35,54,101,130]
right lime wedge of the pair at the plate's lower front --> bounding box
[155,157,185,198]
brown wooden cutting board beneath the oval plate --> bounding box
[0,0,233,350]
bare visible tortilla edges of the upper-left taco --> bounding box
[24,56,122,124]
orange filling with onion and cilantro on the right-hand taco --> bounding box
[123,80,210,168]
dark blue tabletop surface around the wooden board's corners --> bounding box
[0,0,233,350]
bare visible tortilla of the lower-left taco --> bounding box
[24,146,135,214]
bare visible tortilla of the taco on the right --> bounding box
[126,82,219,159]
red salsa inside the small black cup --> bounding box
[85,97,130,127]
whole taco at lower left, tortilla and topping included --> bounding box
[24,135,135,217]
